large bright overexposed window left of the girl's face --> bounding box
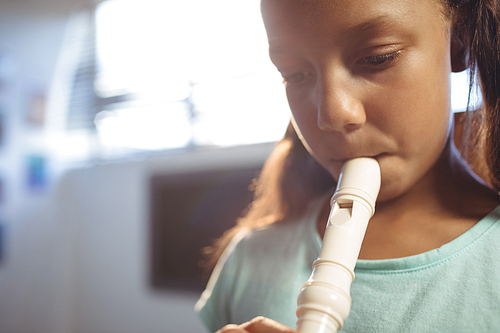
[95,0,290,150]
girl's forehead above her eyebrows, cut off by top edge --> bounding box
[261,0,447,42]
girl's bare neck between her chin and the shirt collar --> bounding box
[318,140,500,259]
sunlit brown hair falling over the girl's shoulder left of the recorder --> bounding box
[204,124,335,269]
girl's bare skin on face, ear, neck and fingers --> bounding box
[221,0,499,333]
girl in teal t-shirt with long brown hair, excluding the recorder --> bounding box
[197,0,500,332]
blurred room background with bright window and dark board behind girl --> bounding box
[0,0,476,333]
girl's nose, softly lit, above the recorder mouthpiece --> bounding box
[317,74,366,134]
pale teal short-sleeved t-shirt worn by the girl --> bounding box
[196,198,500,333]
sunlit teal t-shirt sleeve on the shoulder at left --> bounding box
[195,230,248,332]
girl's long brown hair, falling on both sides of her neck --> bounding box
[206,0,500,268]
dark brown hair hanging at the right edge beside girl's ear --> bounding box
[454,0,500,190]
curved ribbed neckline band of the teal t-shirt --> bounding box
[307,197,500,273]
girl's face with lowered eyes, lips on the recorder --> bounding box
[262,0,451,200]
